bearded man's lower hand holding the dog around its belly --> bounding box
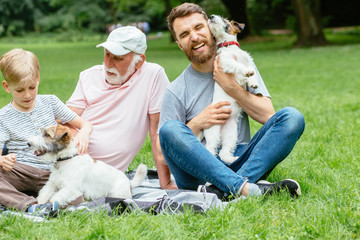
[187,101,231,135]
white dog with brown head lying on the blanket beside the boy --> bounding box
[28,125,147,206]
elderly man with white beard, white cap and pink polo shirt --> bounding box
[66,26,176,188]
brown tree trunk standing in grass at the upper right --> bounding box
[291,0,328,47]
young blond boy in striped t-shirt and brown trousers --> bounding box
[0,49,92,212]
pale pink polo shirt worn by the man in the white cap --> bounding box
[66,62,169,171]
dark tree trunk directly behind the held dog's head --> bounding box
[221,0,251,39]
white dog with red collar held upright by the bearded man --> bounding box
[204,15,258,163]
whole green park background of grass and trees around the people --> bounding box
[0,0,360,239]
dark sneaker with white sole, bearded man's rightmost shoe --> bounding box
[256,179,301,197]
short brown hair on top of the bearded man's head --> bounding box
[167,3,208,40]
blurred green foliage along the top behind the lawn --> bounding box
[0,0,359,37]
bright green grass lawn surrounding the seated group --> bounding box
[0,31,360,239]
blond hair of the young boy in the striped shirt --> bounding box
[0,48,40,85]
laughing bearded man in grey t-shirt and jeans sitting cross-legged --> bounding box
[158,3,304,197]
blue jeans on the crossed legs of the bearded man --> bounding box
[159,107,305,194]
